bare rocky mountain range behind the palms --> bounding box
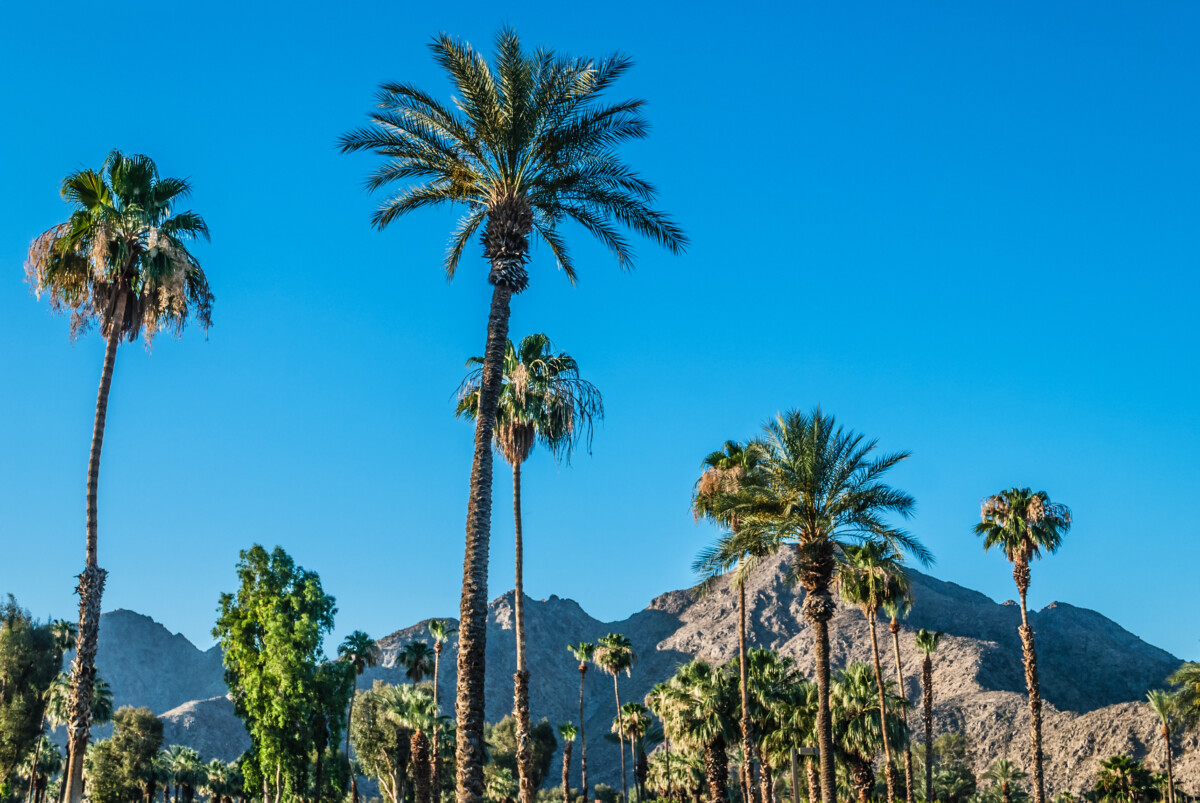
[88,556,1200,795]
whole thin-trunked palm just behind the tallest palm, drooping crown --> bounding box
[456,334,604,803]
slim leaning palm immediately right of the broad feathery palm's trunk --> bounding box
[836,541,908,803]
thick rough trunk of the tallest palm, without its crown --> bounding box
[451,283,512,803]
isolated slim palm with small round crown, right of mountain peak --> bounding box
[974,487,1070,803]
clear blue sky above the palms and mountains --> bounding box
[0,1,1200,659]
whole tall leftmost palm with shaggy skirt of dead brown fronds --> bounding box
[25,150,212,803]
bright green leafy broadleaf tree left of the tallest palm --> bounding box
[212,544,338,803]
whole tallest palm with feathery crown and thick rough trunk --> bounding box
[341,29,686,803]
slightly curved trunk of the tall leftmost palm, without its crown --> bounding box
[65,287,126,803]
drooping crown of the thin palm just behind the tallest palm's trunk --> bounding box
[455,334,604,466]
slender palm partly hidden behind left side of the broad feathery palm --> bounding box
[691,441,774,803]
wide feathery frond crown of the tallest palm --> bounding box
[341,29,686,283]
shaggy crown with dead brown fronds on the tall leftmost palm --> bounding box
[25,150,212,342]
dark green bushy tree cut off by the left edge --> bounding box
[0,594,62,783]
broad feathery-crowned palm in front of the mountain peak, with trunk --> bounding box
[736,408,932,802]
